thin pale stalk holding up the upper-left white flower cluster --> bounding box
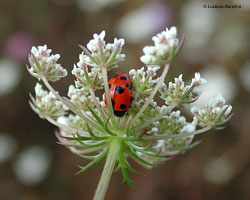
[42,77,100,130]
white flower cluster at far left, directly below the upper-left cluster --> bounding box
[30,83,68,119]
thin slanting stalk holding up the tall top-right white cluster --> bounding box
[127,63,170,124]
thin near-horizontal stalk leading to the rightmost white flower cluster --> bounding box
[143,126,212,140]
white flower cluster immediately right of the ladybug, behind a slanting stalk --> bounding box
[129,66,160,99]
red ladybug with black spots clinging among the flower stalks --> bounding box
[105,72,134,117]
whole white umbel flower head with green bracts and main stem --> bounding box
[28,27,232,200]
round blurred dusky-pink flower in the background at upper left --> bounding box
[4,32,34,61]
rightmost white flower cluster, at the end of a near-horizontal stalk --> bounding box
[191,93,232,129]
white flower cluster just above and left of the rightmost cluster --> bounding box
[159,73,207,105]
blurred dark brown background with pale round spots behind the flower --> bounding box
[0,0,250,200]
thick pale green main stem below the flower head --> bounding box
[93,139,121,200]
